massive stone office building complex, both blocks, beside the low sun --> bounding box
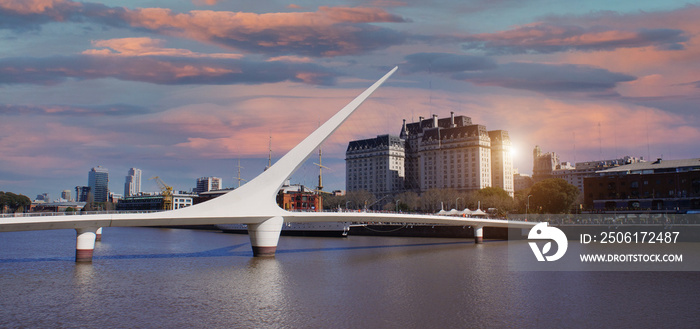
[345,113,514,197]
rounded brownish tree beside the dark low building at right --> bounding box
[530,178,579,214]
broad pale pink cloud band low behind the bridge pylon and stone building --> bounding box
[0,82,700,184]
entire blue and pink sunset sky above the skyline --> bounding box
[0,0,700,199]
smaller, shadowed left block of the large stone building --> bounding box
[345,135,405,197]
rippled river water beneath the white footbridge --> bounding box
[0,228,700,328]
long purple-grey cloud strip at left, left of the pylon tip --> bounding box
[0,55,337,85]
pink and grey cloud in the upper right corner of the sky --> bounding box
[454,5,700,98]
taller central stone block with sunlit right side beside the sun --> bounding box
[401,113,513,195]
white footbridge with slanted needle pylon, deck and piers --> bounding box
[0,67,536,262]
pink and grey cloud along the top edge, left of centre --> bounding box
[0,0,407,57]
